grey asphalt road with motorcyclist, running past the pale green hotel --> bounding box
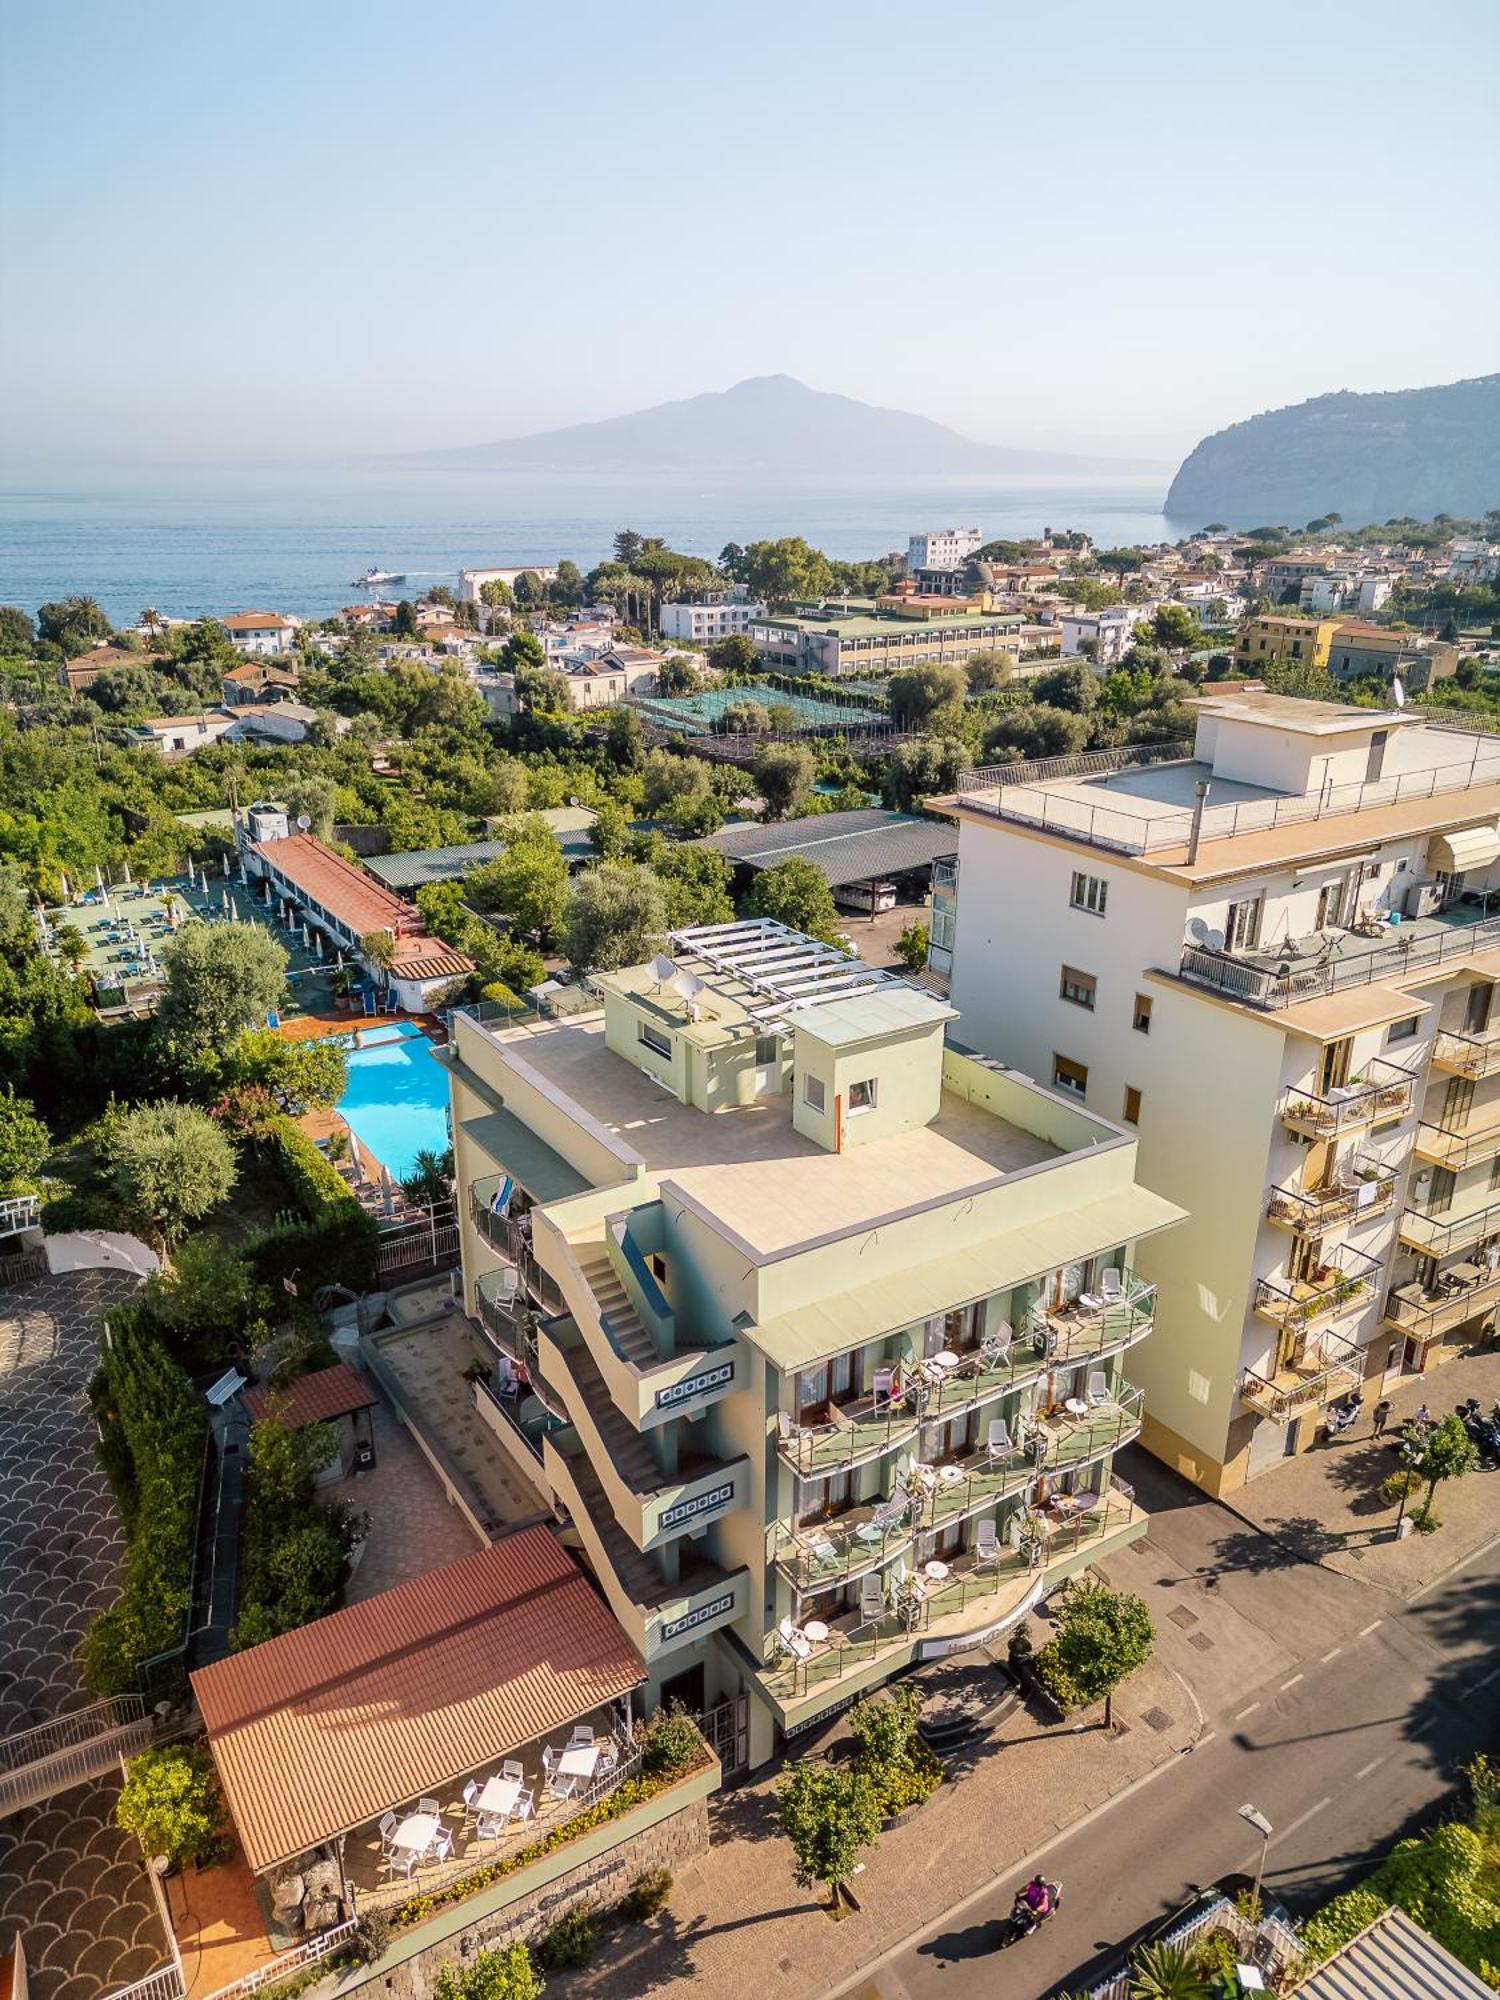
[840,1512,1500,2000]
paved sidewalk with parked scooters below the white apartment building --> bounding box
[1224,1348,1500,1598]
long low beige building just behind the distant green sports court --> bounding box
[750,596,1024,676]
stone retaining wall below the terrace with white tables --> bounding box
[342,1798,708,2000]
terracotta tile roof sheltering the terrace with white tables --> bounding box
[192,1528,646,1874]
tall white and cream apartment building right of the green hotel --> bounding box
[934,694,1500,1492]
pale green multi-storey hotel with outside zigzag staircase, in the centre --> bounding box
[448,920,1180,1762]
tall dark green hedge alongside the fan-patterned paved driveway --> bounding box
[84,1306,206,1694]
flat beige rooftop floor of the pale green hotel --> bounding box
[470,1014,1072,1256]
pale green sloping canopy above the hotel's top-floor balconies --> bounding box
[742,1184,1188,1370]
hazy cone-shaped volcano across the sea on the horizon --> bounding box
[408,376,1140,482]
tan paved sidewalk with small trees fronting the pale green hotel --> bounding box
[548,1656,1198,2000]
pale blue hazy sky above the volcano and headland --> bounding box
[0,0,1500,460]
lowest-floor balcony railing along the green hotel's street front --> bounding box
[764,1480,1142,1702]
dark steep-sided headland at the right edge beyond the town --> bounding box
[1166,374,1500,528]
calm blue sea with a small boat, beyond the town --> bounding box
[0,466,1198,624]
